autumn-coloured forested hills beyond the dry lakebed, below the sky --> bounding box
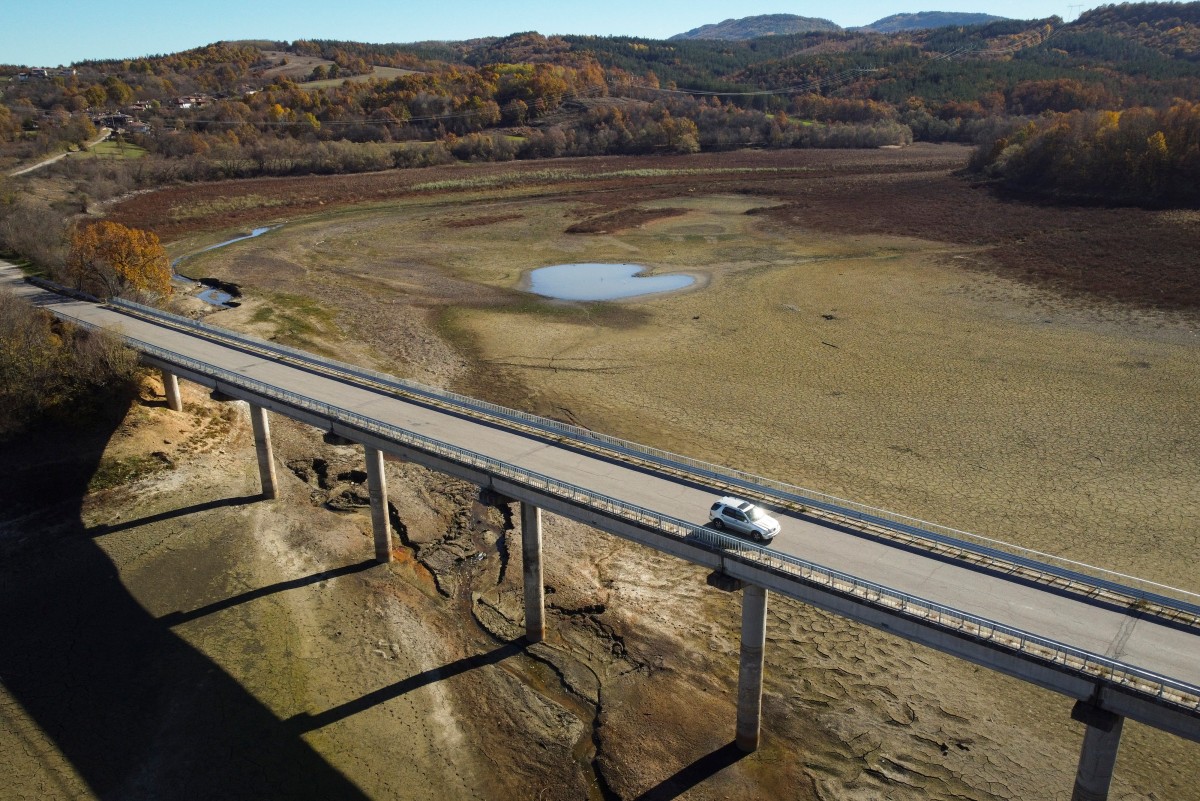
[0,2,1200,216]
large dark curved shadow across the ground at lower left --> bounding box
[0,395,367,801]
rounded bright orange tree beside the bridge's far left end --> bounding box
[64,221,172,297]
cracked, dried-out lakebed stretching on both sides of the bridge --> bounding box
[0,149,1200,800]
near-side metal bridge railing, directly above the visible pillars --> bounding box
[91,323,1200,710]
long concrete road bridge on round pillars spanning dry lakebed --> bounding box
[9,272,1200,801]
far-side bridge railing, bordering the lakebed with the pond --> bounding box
[110,299,1200,616]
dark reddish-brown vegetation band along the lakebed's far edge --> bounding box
[112,145,1200,309]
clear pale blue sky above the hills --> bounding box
[0,0,1103,67]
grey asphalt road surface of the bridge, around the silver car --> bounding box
[4,270,1200,733]
